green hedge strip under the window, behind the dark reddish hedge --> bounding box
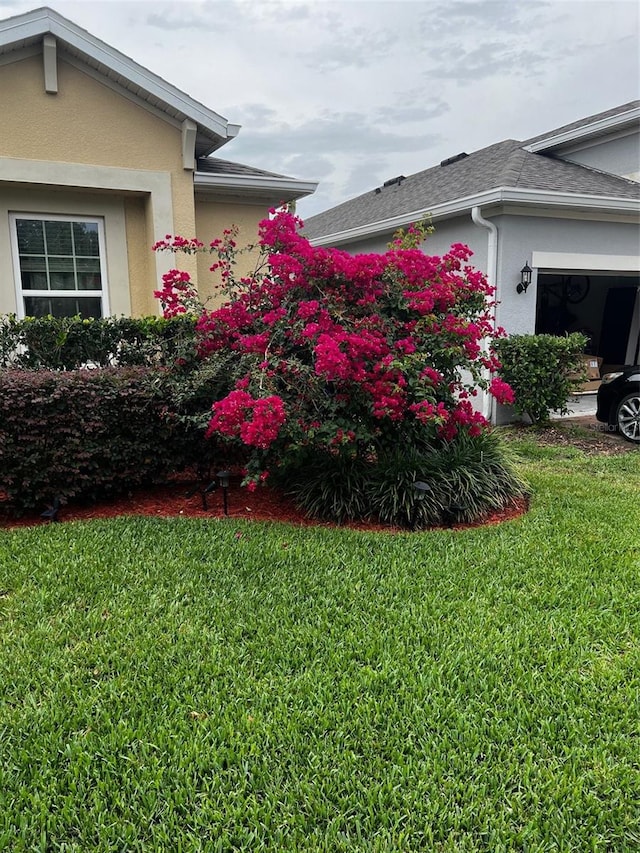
[0,315,195,370]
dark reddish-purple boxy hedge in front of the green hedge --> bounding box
[0,368,192,514]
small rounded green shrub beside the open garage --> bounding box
[495,332,587,424]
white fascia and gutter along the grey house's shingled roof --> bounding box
[310,187,639,246]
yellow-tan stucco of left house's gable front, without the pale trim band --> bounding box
[0,50,197,314]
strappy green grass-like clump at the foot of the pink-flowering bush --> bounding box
[276,432,526,529]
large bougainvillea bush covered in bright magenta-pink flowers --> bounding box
[155,211,513,490]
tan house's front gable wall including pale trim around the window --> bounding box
[0,55,197,315]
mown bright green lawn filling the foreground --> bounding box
[0,441,640,853]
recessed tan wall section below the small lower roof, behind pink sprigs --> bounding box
[194,196,267,307]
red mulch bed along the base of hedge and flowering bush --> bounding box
[0,478,527,533]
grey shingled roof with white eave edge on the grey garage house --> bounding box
[304,108,640,243]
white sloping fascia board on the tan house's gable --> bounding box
[0,8,235,140]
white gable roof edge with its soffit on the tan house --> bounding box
[0,7,240,156]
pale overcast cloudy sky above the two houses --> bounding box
[0,0,640,219]
